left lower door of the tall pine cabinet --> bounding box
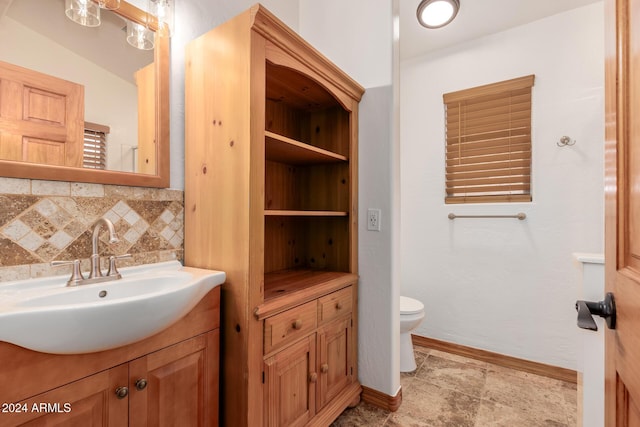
[264,334,318,427]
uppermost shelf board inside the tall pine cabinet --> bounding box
[264,131,348,165]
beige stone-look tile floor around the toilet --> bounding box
[332,346,577,427]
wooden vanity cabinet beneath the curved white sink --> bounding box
[0,287,220,427]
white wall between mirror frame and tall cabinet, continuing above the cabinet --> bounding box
[170,0,298,190]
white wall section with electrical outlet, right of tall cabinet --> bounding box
[300,0,400,396]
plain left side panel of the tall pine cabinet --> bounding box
[185,12,252,426]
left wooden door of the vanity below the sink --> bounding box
[0,364,129,427]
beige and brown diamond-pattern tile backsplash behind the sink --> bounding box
[0,178,184,282]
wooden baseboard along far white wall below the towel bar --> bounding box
[411,335,578,384]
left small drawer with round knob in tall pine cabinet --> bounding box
[264,301,317,354]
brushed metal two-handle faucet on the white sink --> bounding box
[51,218,131,286]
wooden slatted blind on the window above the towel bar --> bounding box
[443,75,535,203]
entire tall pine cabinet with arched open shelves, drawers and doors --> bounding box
[185,5,364,427]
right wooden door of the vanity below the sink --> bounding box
[129,329,219,427]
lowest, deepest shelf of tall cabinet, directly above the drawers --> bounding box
[254,269,358,319]
